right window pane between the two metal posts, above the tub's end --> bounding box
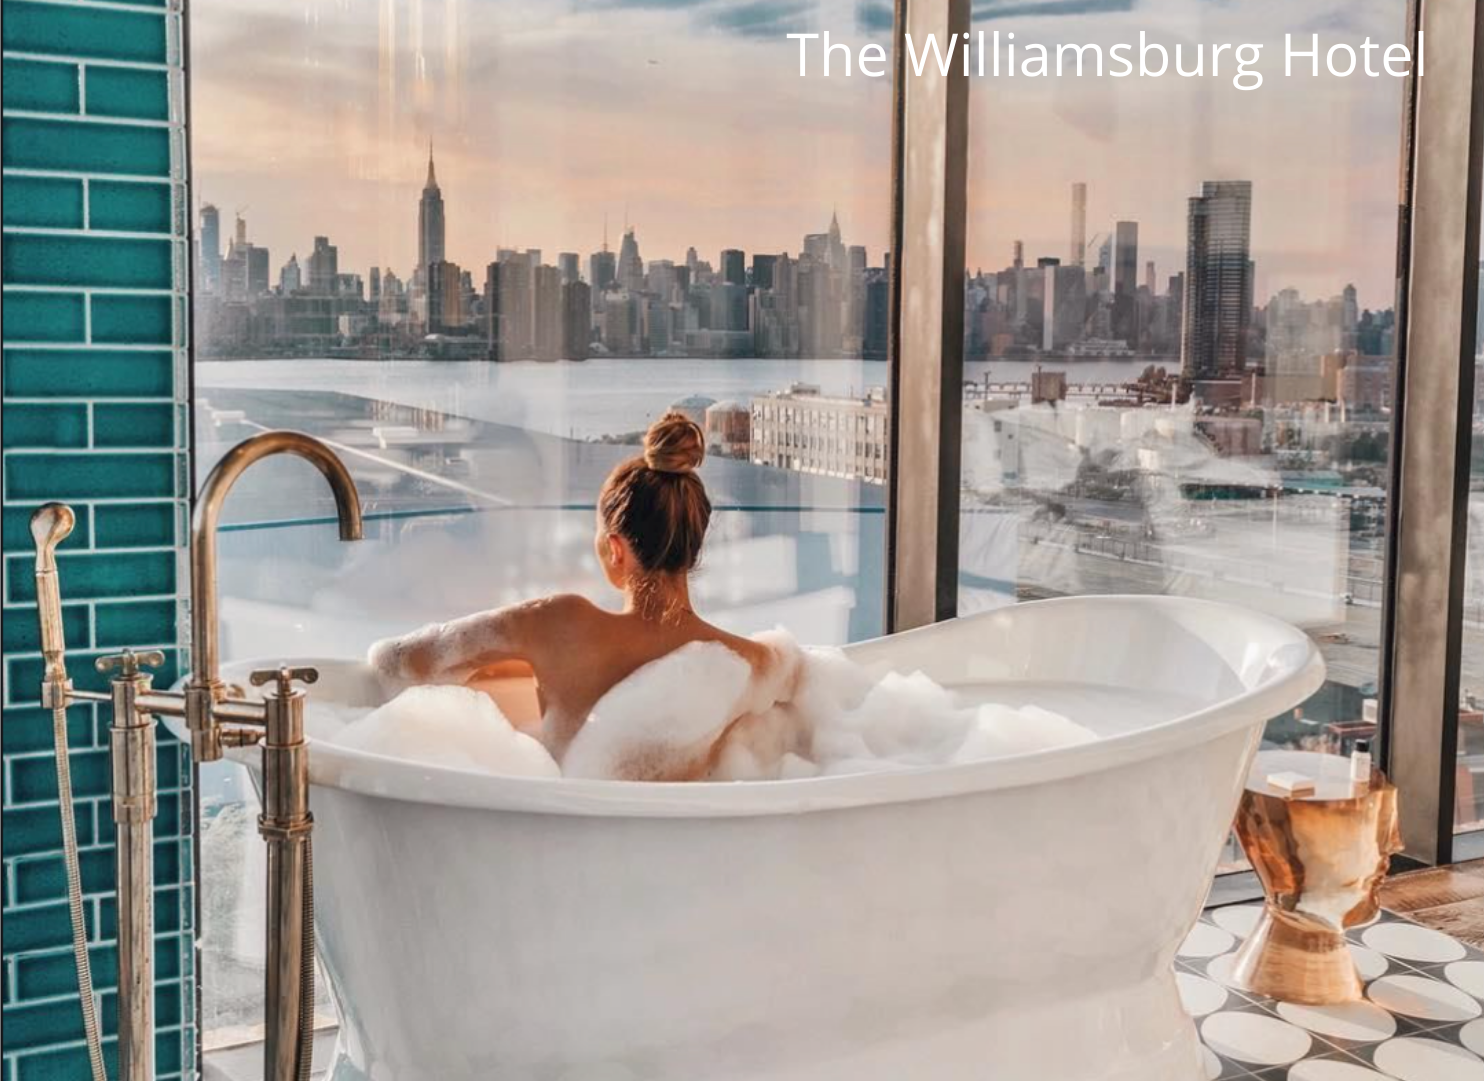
[959,0,1407,867]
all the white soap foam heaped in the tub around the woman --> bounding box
[306,631,1097,781]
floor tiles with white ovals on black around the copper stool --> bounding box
[1175,904,1484,1081]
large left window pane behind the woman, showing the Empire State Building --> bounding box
[191,0,892,1045]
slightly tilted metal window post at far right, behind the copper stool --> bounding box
[1385,0,1484,864]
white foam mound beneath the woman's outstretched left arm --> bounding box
[325,686,561,777]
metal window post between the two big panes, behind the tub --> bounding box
[886,0,969,631]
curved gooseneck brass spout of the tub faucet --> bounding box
[186,431,362,762]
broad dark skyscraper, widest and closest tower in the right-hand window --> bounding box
[1180,180,1252,379]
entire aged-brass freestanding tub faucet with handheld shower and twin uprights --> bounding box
[31,431,362,1081]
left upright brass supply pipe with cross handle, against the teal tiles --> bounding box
[96,649,165,1081]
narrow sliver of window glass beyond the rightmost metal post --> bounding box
[1453,215,1484,832]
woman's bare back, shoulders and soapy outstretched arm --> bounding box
[371,594,778,762]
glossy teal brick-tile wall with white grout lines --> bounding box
[0,0,196,1081]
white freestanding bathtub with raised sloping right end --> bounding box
[212,597,1324,1081]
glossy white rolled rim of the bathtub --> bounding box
[188,594,1325,818]
